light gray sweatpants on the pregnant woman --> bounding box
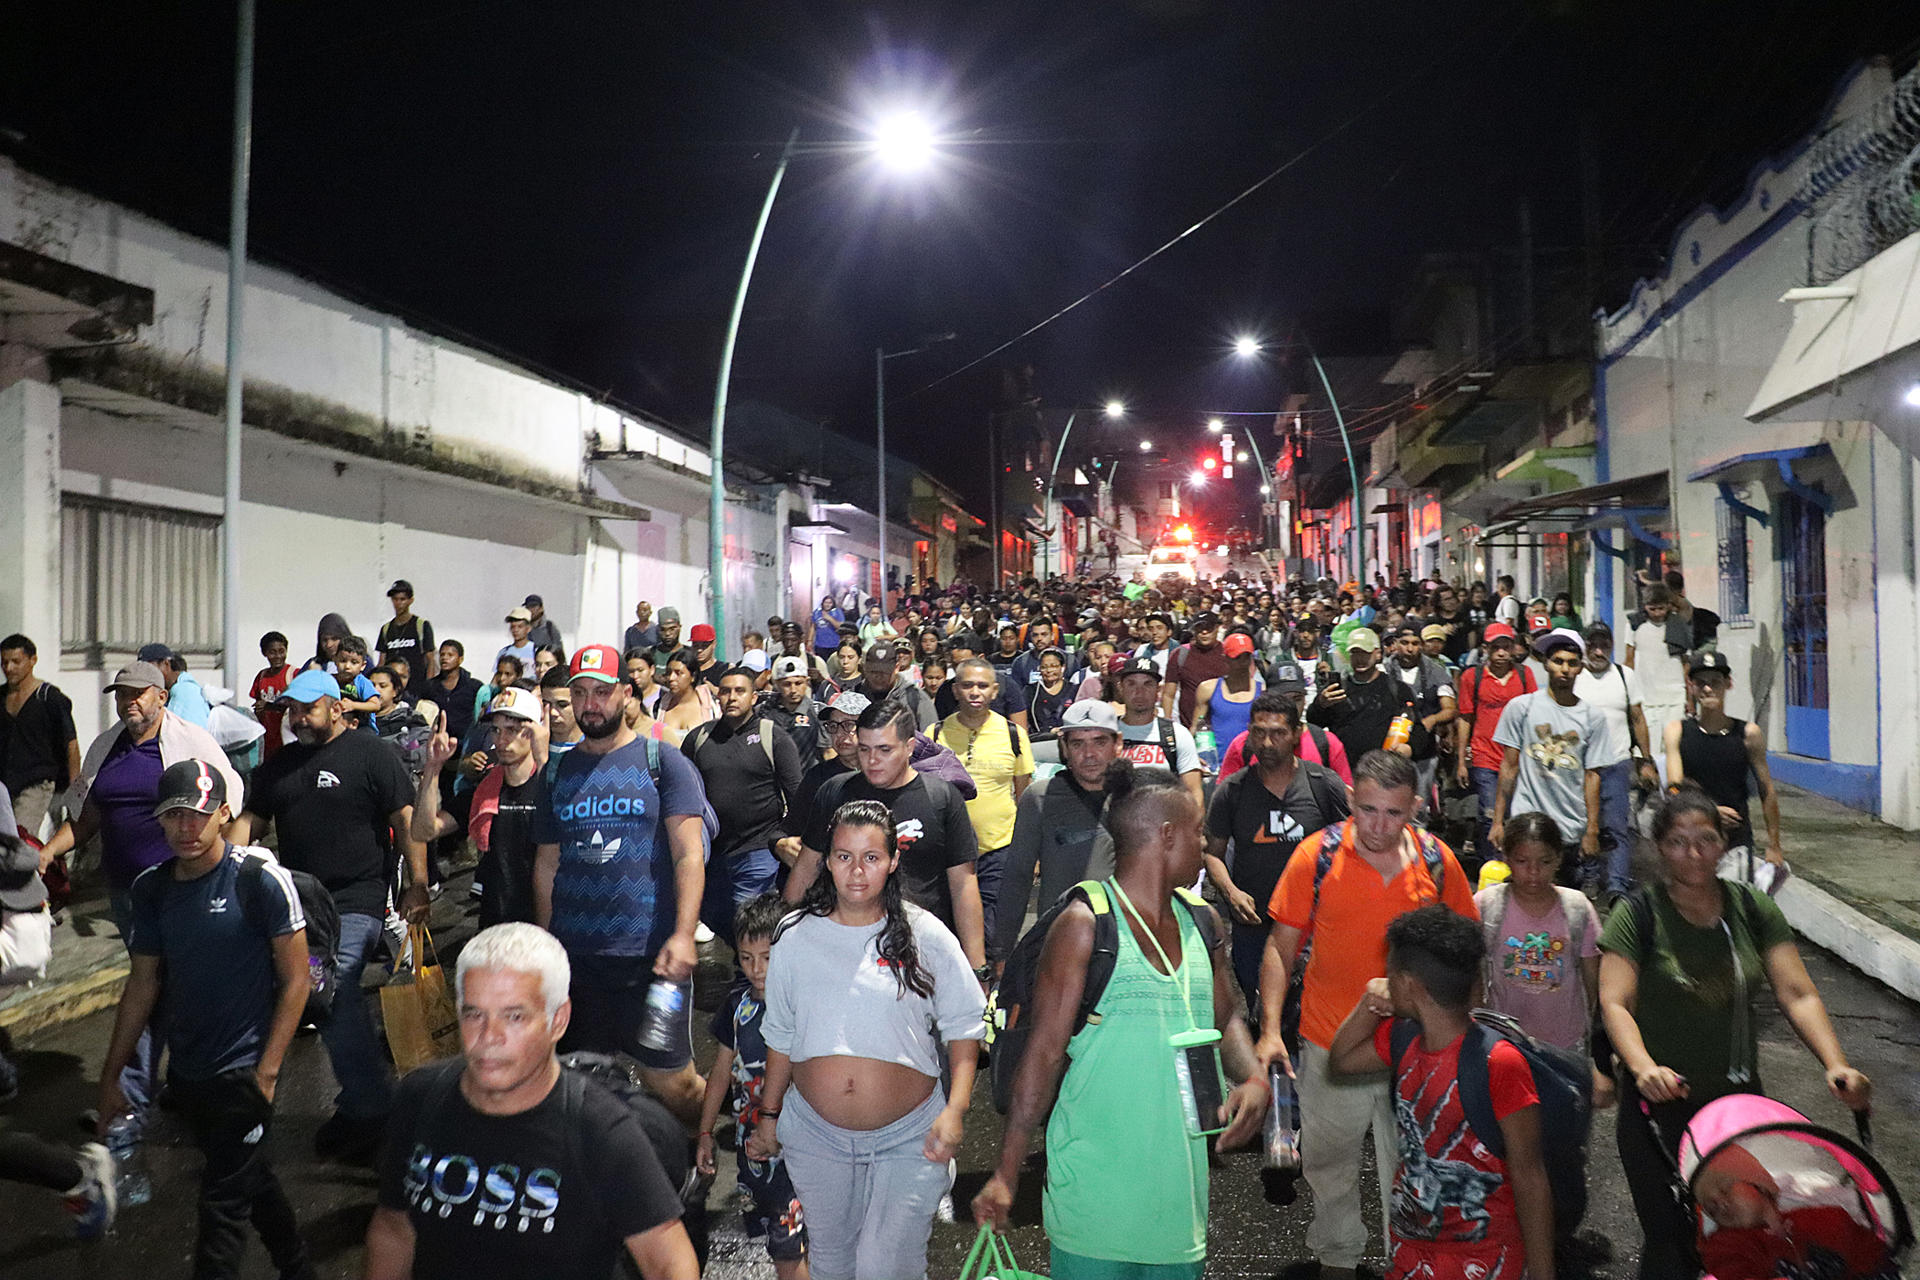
[778,1088,952,1280]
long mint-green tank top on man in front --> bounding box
[1043,881,1213,1265]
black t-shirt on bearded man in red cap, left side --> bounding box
[246,729,413,915]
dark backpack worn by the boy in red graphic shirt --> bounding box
[1390,1009,1594,1240]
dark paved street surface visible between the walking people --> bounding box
[0,882,1920,1280]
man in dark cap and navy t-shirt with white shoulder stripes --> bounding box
[100,760,313,1276]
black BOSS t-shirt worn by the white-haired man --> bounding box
[380,1059,682,1280]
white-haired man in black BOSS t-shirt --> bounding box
[367,923,699,1280]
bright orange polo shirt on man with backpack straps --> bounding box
[1267,823,1480,1050]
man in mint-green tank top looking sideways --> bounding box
[973,760,1267,1280]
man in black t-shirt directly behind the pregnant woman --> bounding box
[785,702,991,981]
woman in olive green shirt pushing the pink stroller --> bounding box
[1599,787,1872,1280]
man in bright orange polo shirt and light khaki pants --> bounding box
[1256,750,1478,1280]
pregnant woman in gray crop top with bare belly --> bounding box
[747,800,985,1280]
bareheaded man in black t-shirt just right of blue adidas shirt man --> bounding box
[680,666,801,946]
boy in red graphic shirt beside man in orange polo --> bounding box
[1331,906,1553,1280]
